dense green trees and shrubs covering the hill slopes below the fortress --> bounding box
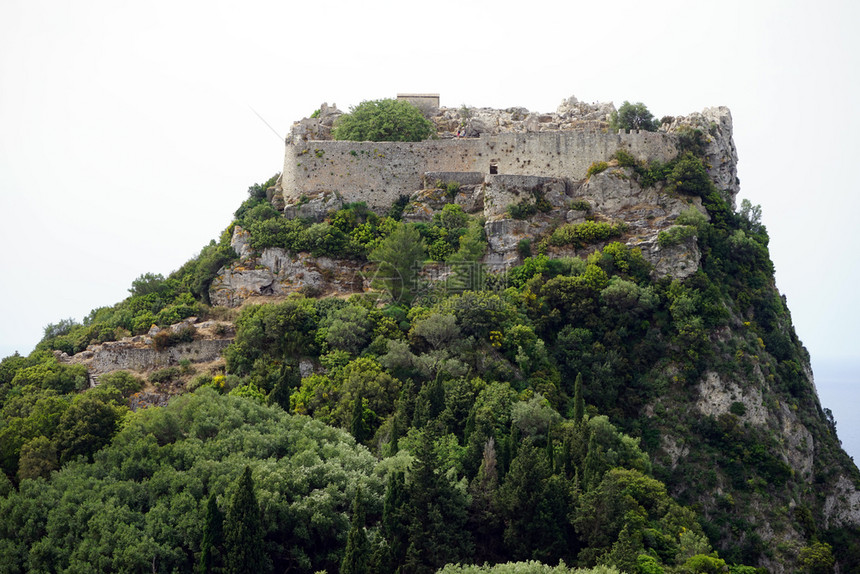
[0,141,860,574]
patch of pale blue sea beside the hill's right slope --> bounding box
[812,356,860,464]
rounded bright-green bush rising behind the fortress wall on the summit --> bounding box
[332,99,435,142]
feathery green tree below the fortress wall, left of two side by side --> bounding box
[367,223,427,305]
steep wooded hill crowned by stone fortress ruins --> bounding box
[0,98,860,574]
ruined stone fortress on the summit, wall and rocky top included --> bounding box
[280,94,738,215]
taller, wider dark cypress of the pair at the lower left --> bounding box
[224,466,266,574]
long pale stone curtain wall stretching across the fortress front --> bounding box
[282,130,677,211]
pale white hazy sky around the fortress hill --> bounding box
[0,0,860,454]
